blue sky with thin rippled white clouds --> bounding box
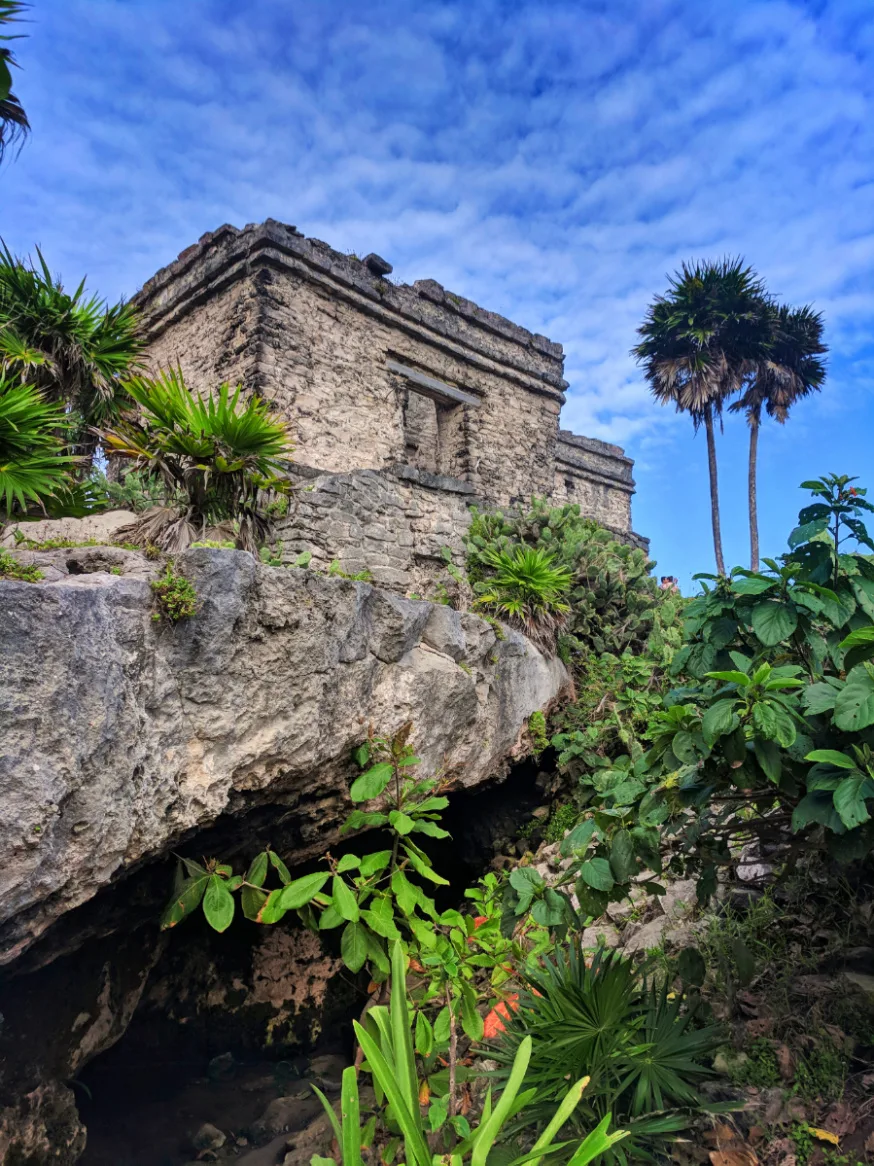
[0,0,874,590]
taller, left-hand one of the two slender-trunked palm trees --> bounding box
[632,259,769,575]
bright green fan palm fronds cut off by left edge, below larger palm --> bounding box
[0,375,73,515]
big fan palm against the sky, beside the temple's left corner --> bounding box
[0,243,143,465]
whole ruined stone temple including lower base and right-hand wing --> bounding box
[136,219,643,592]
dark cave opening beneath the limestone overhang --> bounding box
[60,759,554,1166]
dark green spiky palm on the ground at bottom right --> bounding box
[489,940,721,1163]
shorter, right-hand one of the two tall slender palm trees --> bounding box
[731,304,829,571]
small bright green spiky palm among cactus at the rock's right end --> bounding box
[474,545,571,652]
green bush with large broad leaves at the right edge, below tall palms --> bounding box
[561,475,874,899]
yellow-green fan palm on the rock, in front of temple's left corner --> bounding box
[101,370,292,552]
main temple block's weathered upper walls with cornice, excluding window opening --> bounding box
[138,220,565,504]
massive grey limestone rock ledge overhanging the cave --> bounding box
[0,548,566,963]
